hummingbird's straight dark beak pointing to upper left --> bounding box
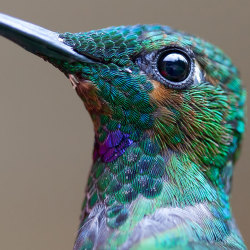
[0,13,96,63]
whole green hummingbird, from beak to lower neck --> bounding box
[0,14,246,250]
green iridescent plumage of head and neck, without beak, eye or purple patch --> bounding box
[50,25,245,249]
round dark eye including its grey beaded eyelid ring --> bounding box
[152,46,195,89]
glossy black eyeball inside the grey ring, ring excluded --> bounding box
[157,51,190,82]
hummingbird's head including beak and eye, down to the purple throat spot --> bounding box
[1,15,245,184]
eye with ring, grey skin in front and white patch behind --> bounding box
[135,46,203,89]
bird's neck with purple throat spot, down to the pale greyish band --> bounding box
[84,129,233,224]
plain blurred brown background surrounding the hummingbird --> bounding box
[0,0,250,250]
